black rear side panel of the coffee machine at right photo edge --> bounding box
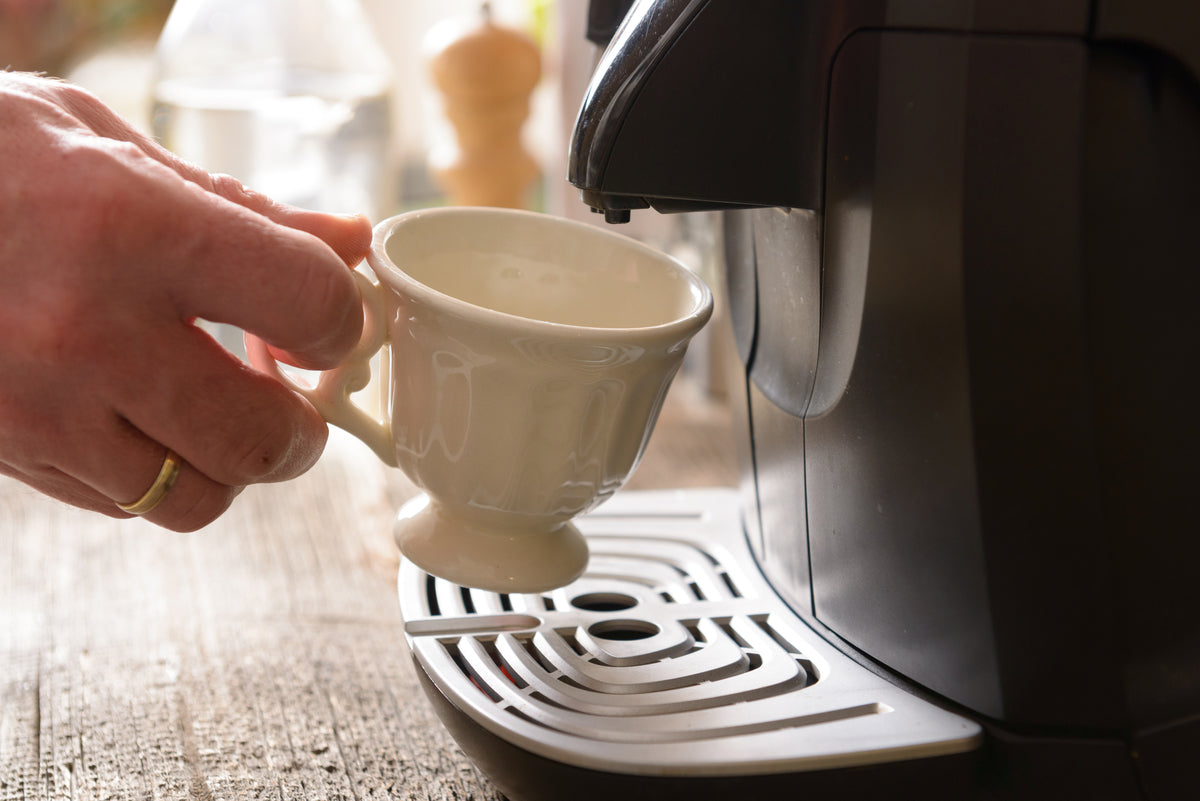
[1084,42,1200,738]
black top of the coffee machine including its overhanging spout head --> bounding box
[568,0,1200,222]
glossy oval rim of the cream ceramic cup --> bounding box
[367,206,713,341]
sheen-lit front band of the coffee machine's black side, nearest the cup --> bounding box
[806,34,1003,716]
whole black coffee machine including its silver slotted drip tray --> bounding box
[401,0,1200,801]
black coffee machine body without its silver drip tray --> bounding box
[569,0,1200,799]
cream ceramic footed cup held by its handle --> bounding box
[247,207,713,592]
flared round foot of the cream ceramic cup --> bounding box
[392,495,588,594]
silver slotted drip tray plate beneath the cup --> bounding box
[400,489,982,776]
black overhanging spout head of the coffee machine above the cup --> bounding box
[568,0,864,222]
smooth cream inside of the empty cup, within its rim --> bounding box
[385,207,707,329]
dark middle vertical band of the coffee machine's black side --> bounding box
[964,37,1127,730]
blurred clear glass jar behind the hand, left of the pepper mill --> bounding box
[152,0,394,221]
